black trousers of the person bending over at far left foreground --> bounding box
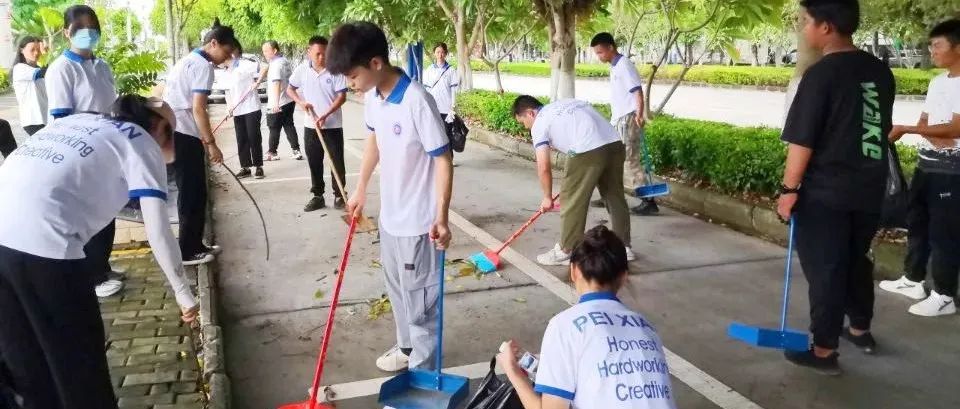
[0,246,117,409]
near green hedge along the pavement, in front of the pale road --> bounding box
[457,91,917,196]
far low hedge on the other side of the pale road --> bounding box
[472,61,941,95]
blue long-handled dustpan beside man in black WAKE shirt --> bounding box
[727,217,810,351]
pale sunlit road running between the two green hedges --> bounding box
[473,72,923,143]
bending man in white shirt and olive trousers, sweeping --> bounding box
[513,95,636,266]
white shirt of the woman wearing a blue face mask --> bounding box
[44,50,117,122]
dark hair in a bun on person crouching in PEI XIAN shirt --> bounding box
[570,225,629,286]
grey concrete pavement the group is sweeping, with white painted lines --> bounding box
[206,103,960,409]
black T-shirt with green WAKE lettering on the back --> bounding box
[781,50,896,213]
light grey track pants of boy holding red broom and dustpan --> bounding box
[380,229,440,369]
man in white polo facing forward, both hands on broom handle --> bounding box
[286,36,347,212]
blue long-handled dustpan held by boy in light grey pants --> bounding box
[378,251,470,409]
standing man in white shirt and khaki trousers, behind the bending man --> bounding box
[590,33,660,216]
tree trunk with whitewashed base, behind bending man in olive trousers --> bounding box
[547,2,577,101]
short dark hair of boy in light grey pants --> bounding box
[326,21,390,74]
